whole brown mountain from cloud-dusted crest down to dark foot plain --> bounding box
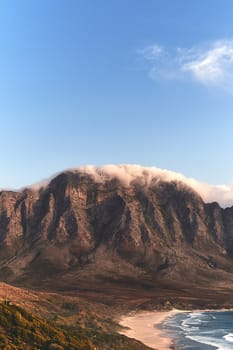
[0,168,233,306]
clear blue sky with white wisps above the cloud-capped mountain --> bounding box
[0,0,233,188]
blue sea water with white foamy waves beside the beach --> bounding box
[163,311,233,350]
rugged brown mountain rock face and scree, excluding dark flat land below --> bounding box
[0,172,233,288]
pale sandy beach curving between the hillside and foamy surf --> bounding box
[119,309,182,350]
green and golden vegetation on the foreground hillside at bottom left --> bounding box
[0,303,151,350]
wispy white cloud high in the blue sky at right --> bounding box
[140,40,233,90]
